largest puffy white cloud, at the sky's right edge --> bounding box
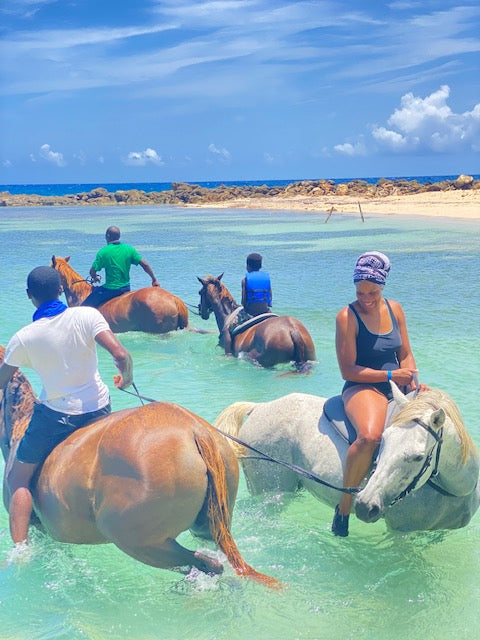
[372,85,480,153]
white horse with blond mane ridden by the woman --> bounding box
[215,384,480,531]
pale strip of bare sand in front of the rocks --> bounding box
[186,190,480,220]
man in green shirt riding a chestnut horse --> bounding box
[82,227,160,307]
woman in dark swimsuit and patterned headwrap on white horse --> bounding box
[332,251,426,537]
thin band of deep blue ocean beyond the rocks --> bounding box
[0,174,480,196]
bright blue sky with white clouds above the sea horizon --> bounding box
[0,0,480,184]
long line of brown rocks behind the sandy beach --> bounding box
[0,174,480,207]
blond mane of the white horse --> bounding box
[390,389,478,464]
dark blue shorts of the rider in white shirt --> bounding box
[16,403,111,464]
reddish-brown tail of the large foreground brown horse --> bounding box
[195,435,281,589]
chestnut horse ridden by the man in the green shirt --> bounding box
[52,256,188,333]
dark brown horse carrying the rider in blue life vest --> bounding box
[198,273,316,371]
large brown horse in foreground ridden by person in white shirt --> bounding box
[0,347,279,587]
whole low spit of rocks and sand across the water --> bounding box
[0,176,480,220]
